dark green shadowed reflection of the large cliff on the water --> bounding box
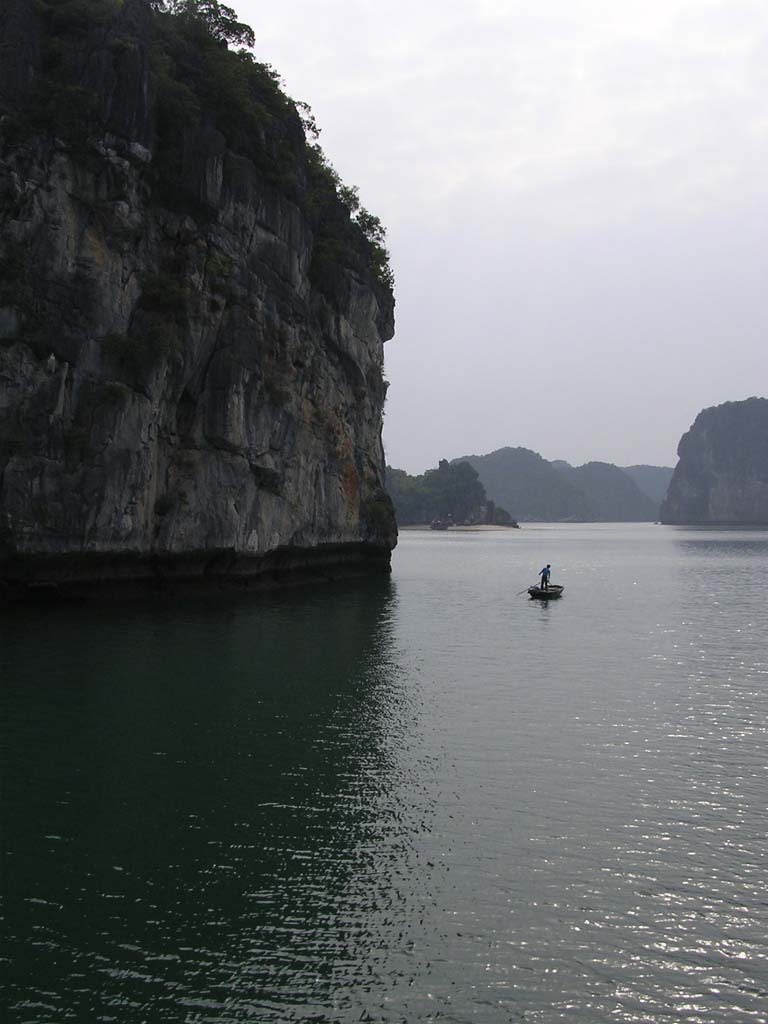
[0,580,428,1022]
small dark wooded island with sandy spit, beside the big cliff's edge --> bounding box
[386,459,517,528]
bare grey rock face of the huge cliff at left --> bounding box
[0,0,396,588]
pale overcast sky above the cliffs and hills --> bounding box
[241,0,768,472]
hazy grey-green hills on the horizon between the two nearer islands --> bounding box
[453,447,672,522]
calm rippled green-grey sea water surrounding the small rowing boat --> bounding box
[0,525,768,1024]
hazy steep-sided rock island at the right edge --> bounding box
[662,398,768,524]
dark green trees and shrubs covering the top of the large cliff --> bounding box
[0,0,393,292]
